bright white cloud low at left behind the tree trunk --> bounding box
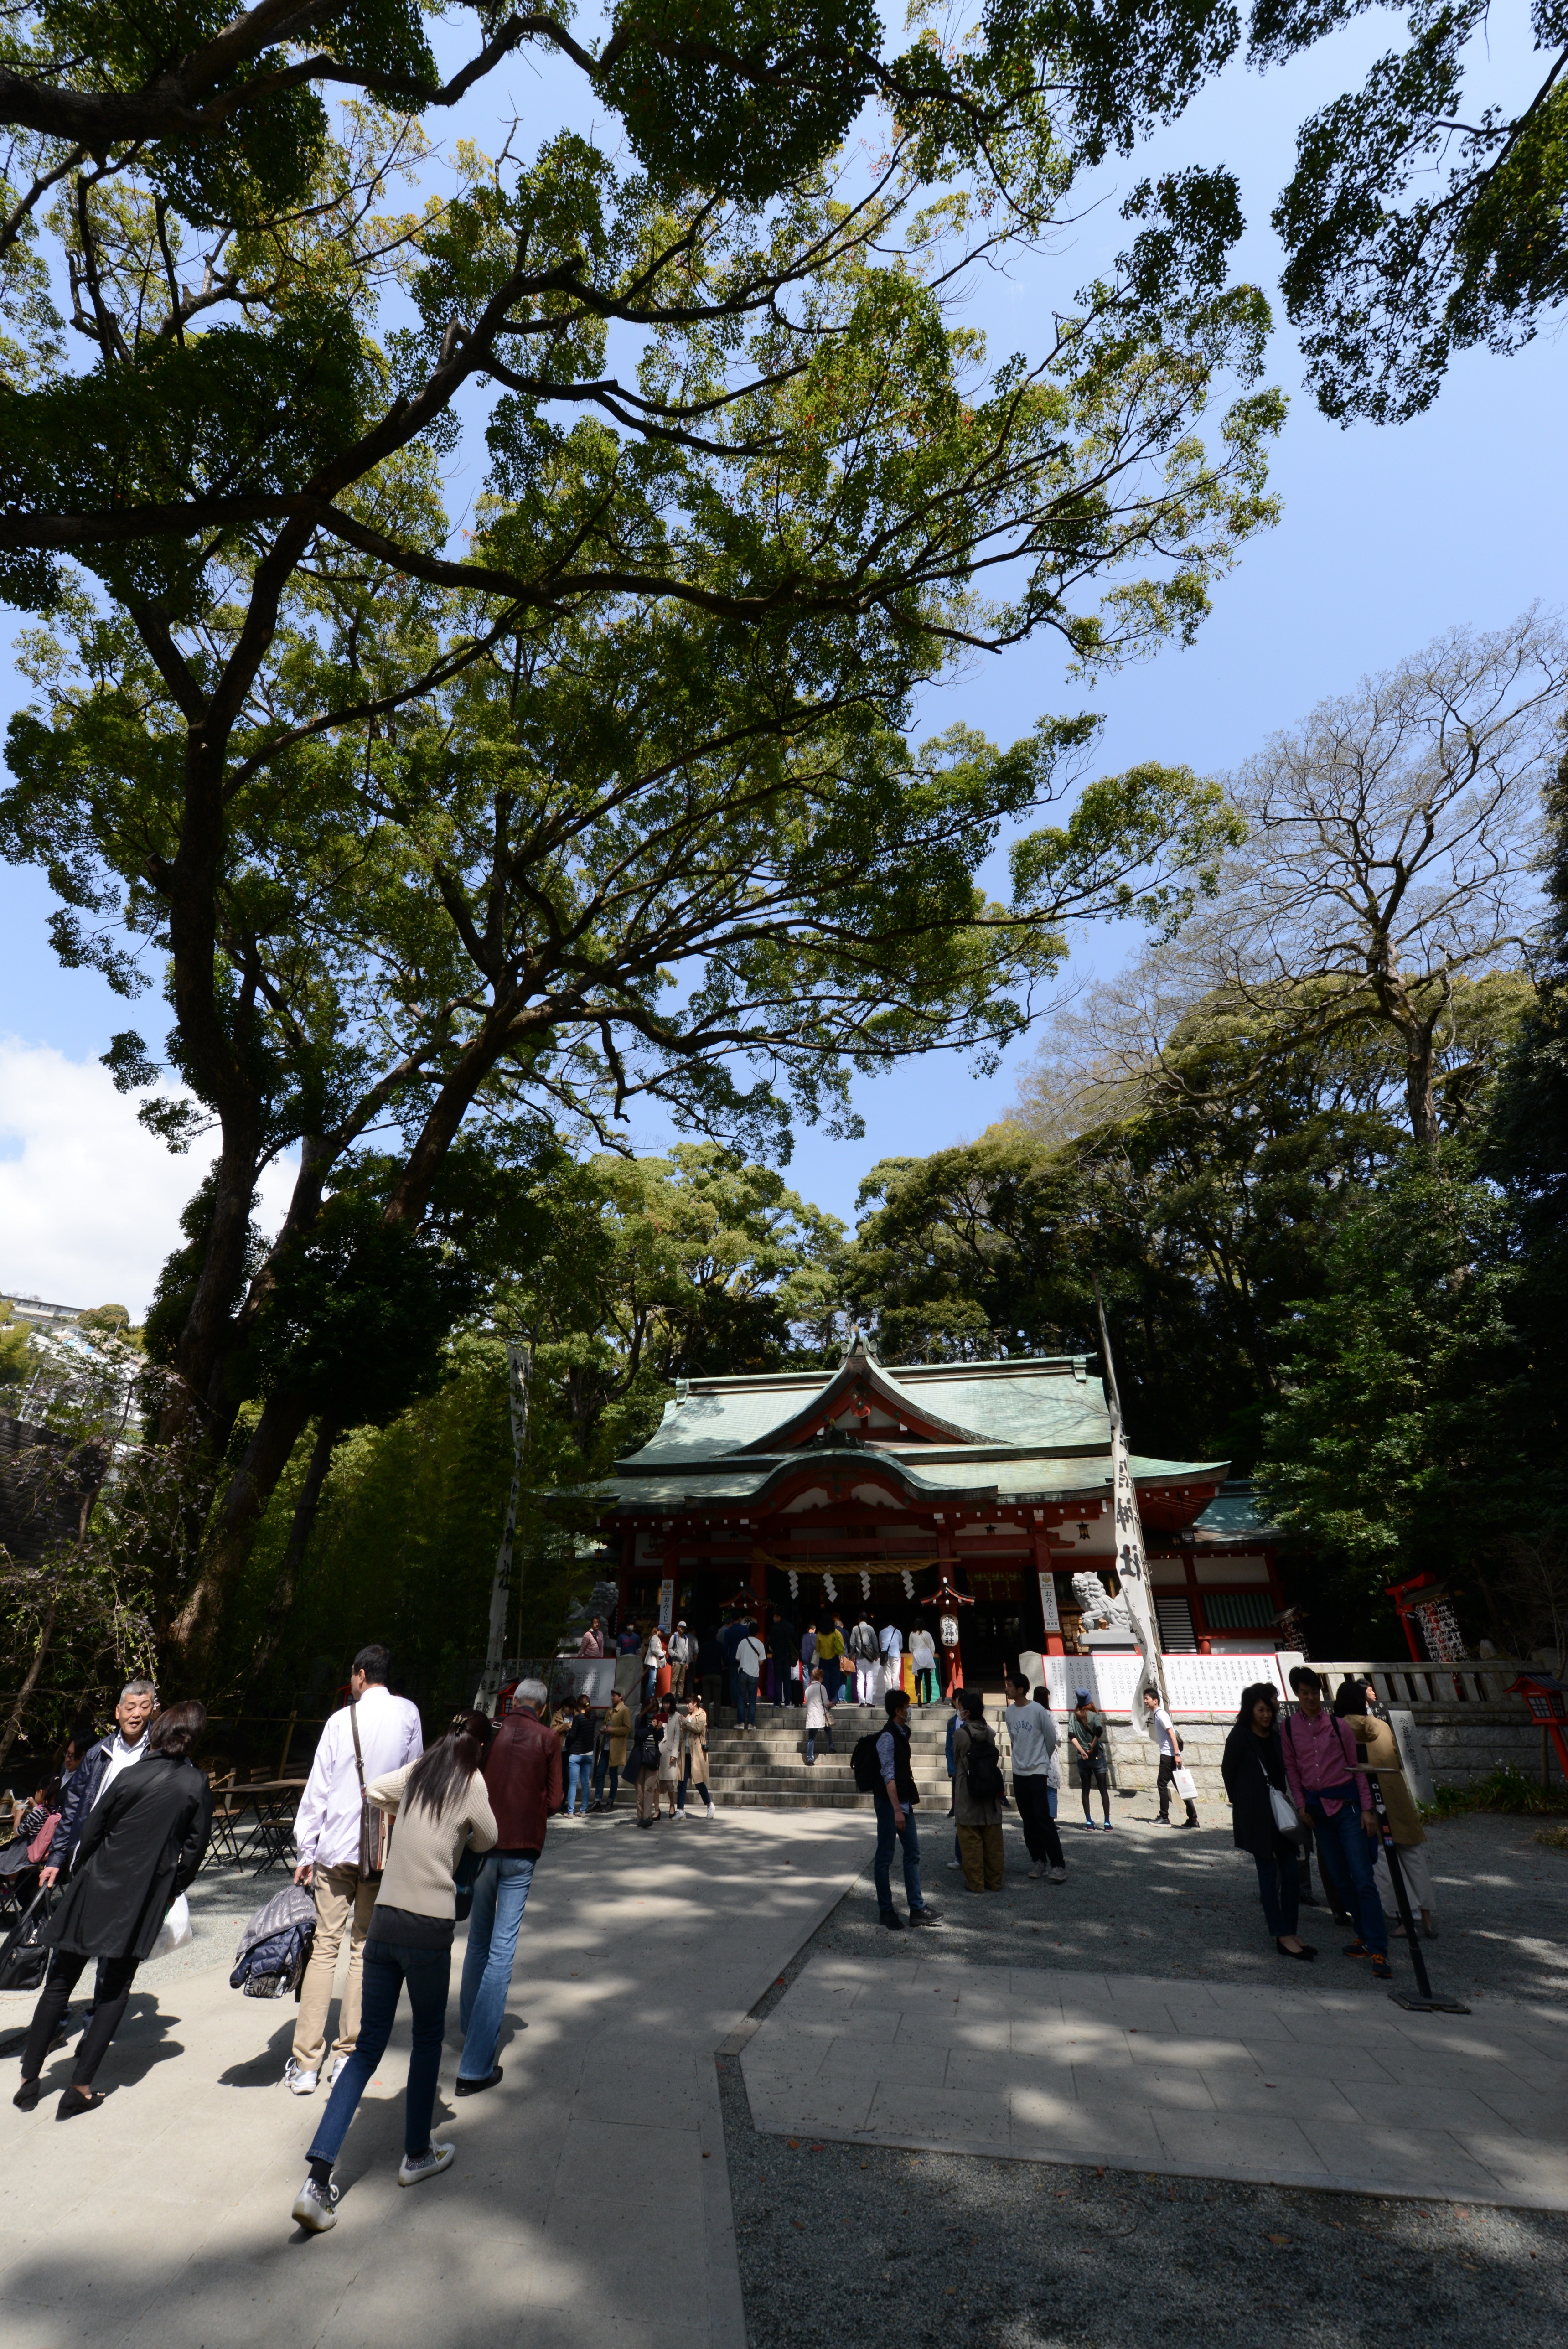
[0,1036,294,1320]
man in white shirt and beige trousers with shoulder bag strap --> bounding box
[284,1644,425,2095]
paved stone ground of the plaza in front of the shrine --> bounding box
[0,1806,1568,2349]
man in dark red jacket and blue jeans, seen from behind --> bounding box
[458,1680,566,2095]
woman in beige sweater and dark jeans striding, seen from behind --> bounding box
[294,1713,495,2234]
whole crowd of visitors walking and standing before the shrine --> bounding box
[0,1614,1437,2234]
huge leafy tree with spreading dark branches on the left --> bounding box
[0,7,1279,1680]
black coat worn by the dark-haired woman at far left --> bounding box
[42,1755,211,1957]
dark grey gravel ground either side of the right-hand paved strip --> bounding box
[718,1802,1568,2349]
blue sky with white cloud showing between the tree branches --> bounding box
[0,14,1568,1311]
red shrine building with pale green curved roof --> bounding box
[594,1336,1284,1682]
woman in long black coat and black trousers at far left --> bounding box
[12,1703,211,2121]
